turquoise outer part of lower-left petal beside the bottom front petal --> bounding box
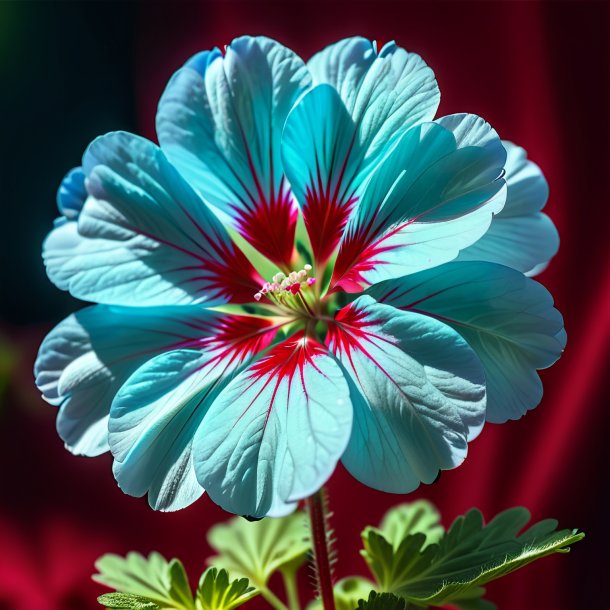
[109,350,222,511]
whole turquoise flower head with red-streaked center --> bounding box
[35,37,565,517]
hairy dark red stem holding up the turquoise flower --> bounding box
[307,488,335,610]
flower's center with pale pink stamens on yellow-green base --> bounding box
[254,265,318,317]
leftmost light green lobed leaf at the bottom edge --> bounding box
[93,552,195,610]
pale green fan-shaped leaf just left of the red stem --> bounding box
[208,512,311,589]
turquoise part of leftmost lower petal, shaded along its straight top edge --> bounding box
[34,305,220,456]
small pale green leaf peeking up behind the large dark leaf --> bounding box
[370,500,445,548]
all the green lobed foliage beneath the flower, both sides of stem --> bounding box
[94,500,584,610]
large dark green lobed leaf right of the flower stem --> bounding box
[362,508,584,610]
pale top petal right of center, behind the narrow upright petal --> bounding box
[307,37,440,163]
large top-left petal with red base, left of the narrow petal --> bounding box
[157,36,311,264]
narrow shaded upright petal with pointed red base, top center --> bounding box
[282,85,362,264]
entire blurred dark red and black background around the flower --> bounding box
[0,0,610,610]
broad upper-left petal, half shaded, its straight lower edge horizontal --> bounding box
[44,132,260,305]
